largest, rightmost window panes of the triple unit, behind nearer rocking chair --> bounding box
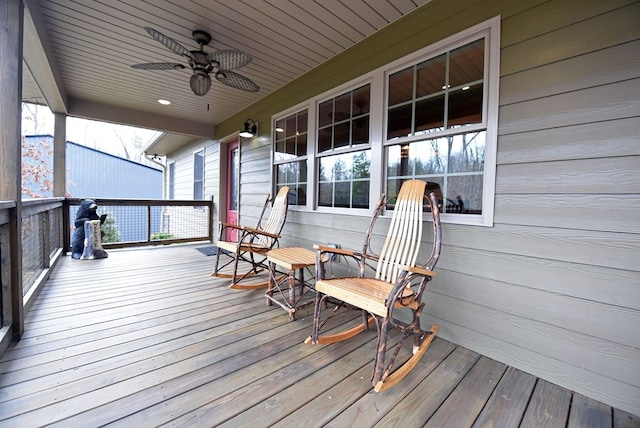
[385,37,487,219]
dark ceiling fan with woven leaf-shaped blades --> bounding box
[131,27,260,96]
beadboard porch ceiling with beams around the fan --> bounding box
[22,0,430,147]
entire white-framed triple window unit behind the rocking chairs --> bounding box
[274,17,500,226]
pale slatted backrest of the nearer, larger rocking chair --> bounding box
[376,180,426,284]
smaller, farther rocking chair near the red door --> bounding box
[211,186,289,290]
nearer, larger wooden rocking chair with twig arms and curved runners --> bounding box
[305,180,442,392]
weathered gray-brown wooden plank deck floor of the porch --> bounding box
[0,244,640,428]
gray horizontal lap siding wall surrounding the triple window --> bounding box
[171,0,640,415]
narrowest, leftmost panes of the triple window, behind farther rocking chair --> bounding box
[274,109,309,205]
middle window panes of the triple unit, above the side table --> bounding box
[317,84,371,208]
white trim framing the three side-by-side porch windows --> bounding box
[271,16,501,227]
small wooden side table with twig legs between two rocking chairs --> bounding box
[265,247,316,321]
